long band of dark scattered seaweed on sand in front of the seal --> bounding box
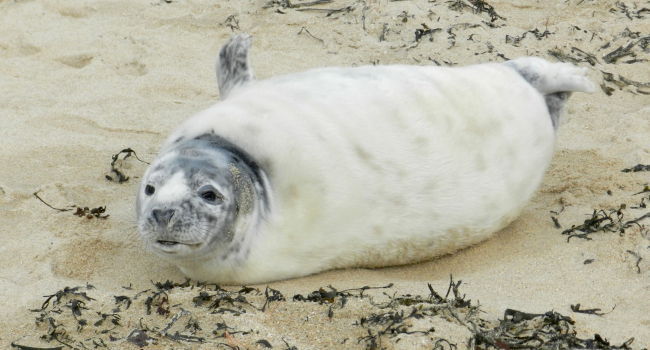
[12,277,633,350]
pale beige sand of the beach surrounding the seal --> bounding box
[0,0,650,349]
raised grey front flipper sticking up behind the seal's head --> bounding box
[217,34,254,100]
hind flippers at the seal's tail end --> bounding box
[504,57,596,129]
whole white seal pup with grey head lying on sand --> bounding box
[137,35,594,284]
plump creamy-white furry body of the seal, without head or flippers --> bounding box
[171,64,554,272]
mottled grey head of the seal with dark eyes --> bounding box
[137,134,268,260]
